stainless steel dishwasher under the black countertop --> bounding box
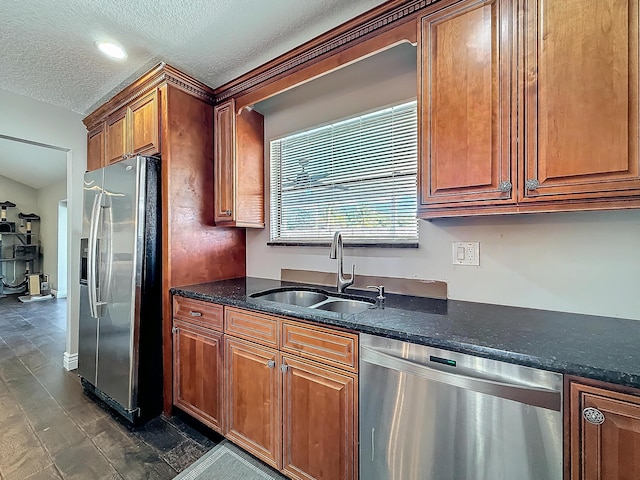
[359,334,563,480]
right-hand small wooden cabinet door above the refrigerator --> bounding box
[129,90,160,155]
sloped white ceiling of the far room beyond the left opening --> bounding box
[0,135,67,189]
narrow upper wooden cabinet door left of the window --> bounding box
[213,100,236,223]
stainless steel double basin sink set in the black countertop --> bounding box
[250,288,376,314]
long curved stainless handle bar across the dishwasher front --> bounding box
[360,345,562,412]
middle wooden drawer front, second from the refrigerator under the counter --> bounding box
[224,307,279,348]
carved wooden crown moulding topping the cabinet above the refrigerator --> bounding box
[82,62,215,130]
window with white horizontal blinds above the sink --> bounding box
[270,101,418,244]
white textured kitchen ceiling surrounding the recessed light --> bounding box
[0,0,384,115]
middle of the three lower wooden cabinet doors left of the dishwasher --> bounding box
[225,336,282,469]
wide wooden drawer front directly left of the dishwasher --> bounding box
[280,321,358,372]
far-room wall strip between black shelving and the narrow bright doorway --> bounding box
[38,180,67,290]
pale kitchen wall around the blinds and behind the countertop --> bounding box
[247,46,640,320]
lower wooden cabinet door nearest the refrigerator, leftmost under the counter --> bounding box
[173,321,224,433]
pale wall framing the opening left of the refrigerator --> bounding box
[0,90,87,368]
